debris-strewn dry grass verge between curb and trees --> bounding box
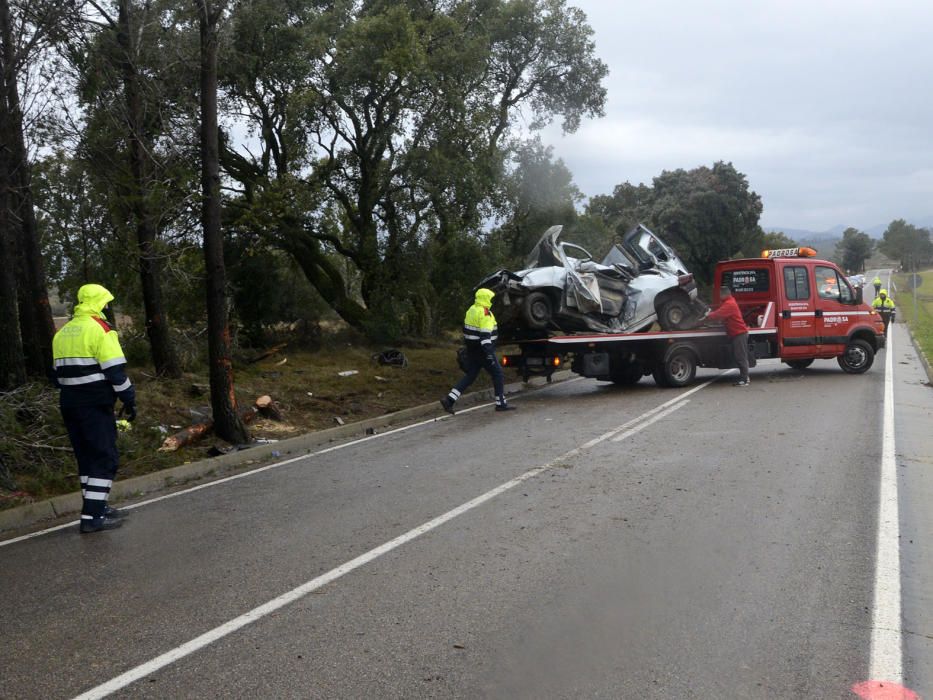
[0,340,502,508]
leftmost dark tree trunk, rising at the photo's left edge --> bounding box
[0,0,55,376]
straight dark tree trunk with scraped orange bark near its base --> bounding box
[195,0,249,443]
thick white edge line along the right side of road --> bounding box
[869,328,903,684]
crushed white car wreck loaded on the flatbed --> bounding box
[478,224,706,336]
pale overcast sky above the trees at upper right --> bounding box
[543,0,933,231]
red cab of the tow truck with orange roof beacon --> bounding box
[713,248,884,373]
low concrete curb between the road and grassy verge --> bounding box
[0,370,573,534]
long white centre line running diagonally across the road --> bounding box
[74,373,724,700]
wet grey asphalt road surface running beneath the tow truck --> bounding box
[0,314,933,698]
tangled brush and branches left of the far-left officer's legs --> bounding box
[0,383,75,508]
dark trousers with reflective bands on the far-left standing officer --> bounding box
[62,405,120,520]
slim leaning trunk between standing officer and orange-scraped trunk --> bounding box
[117,0,181,378]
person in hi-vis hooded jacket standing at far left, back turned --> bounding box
[52,284,136,533]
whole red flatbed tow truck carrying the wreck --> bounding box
[503,248,885,387]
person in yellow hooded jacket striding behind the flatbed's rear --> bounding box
[441,289,515,415]
